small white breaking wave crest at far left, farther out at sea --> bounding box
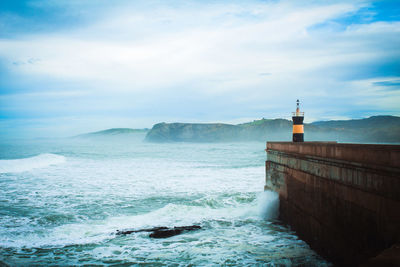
[0,153,65,173]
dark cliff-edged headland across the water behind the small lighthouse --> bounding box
[146,116,400,143]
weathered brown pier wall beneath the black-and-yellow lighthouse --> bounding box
[265,142,400,266]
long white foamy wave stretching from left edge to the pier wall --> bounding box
[0,191,279,248]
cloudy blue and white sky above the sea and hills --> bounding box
[0,0,400,138]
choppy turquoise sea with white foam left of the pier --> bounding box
[0,134,331,266]
